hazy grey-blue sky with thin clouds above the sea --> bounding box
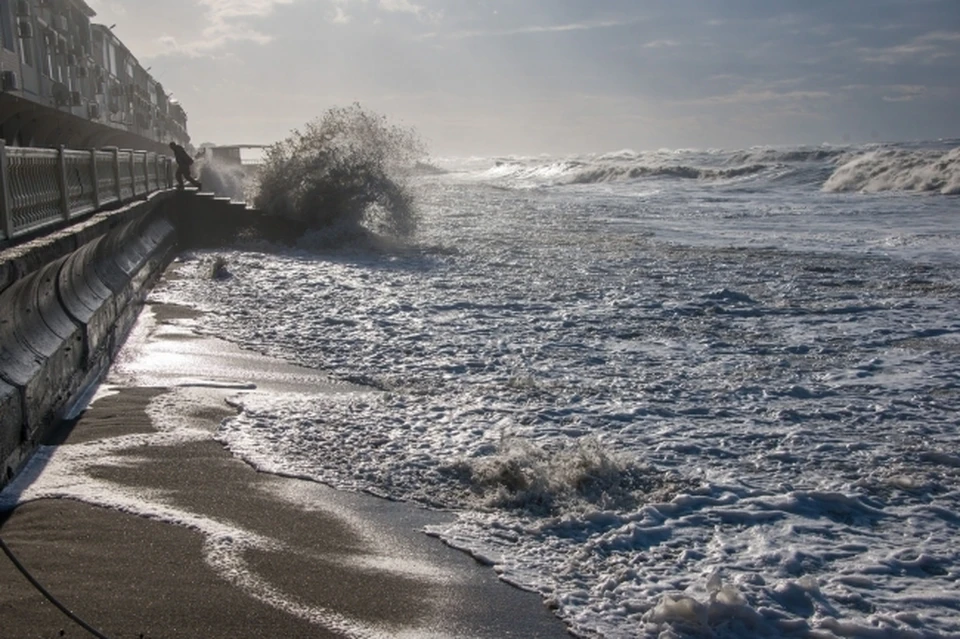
[87,0,960,155]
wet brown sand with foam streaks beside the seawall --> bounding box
[0,307,568,638]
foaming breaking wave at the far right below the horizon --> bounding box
[823,147,960,195]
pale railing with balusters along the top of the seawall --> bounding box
[0,142,175,241]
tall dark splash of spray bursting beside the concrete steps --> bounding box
[254,104,425,236]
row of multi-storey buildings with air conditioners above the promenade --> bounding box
[0,0,190,153]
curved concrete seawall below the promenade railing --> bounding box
[0,193,183,486]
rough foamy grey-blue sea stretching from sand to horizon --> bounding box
[158,140,960,638]
